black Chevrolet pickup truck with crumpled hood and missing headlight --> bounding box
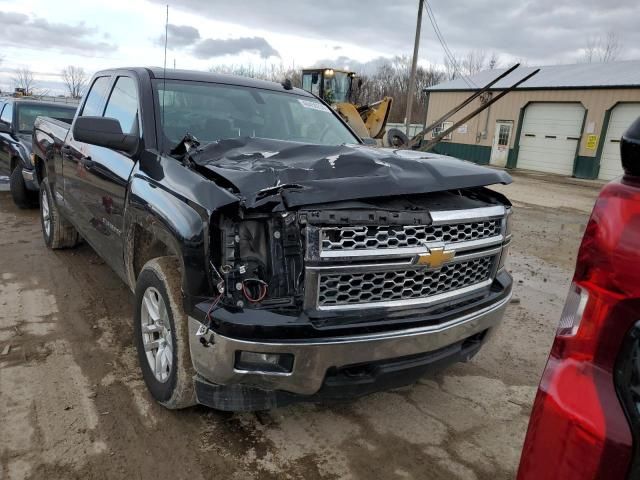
[33,68,512,411]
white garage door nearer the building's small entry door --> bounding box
[517,103,584,175]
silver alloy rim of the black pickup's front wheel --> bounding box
[140,287,173,383]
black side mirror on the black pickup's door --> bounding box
[73,117,138,154]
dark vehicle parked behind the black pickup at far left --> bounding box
[0,98,77,208]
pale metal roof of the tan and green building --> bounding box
[424,60,640,92]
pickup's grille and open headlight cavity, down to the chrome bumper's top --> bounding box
[202,187,511,338]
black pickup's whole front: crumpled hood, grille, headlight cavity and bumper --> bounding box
[176,135,512,410]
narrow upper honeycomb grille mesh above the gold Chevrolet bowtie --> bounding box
[321,218,502,251]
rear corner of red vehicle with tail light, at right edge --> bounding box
[518,118,640,480]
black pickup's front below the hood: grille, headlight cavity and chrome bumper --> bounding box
[190,188,512,411]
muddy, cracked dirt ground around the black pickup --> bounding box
[0,175,598,480]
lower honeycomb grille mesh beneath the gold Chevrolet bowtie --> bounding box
[318,256,496,308]
